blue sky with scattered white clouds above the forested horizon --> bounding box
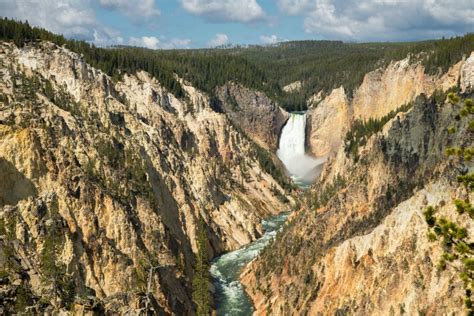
[0,0,474,49]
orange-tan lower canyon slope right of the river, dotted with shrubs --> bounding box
[242,81,474,315]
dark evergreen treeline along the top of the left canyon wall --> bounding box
[0,18,272,98]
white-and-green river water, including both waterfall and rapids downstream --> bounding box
[210,112,324,316]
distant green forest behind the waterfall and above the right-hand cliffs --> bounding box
[236,34,474,108]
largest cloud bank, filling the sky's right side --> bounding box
[278,0,474,40]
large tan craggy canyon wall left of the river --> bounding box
[0,42,288,315]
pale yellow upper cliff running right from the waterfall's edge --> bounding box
[307,56,468,157]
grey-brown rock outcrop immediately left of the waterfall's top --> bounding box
[216,82,289,152]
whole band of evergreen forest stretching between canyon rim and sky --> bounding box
[0,18,474,111]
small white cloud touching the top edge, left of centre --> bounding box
[99,0,160,20]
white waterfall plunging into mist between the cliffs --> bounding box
[277,113,324,186]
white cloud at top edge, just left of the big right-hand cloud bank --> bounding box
[180,0,266,23]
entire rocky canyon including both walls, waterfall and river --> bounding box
[0,30,474,315]
